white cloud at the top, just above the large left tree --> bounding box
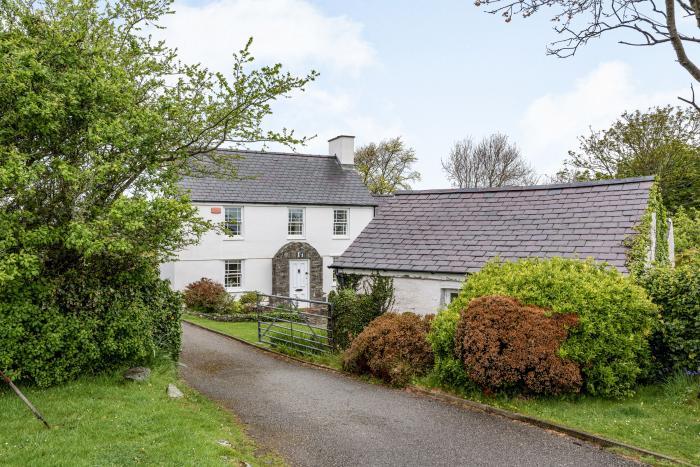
[155,0,375,74]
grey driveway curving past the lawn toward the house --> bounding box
[181,323,638,467]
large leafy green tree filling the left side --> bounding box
[0,0,316,384]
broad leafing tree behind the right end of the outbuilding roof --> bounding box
[560,106,700,212]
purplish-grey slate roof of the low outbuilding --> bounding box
[332,177,653,274]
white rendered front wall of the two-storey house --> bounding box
[161,203,374,293]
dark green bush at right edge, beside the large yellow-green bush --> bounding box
[641,260,700,376]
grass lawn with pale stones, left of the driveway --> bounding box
[0,364,283,466]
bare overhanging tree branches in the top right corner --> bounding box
[475,0,700,110]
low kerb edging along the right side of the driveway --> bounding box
[183,318,693,466]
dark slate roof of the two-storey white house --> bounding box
[180,151,377,206]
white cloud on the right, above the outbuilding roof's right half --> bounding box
[520,61,684,174]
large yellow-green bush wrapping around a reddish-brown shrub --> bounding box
[428,258,657,397]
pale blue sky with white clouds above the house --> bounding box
[152,0,691,189]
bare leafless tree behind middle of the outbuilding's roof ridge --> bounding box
[442,133,537,188]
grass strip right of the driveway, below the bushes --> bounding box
[419,376,700,465]
